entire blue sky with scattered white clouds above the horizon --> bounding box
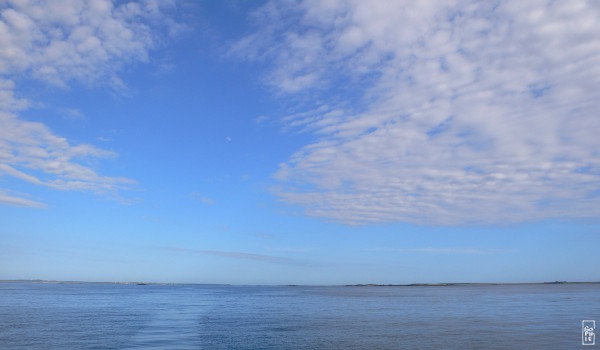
[0,0,600,285]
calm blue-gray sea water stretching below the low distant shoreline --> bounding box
[0,282,600,349]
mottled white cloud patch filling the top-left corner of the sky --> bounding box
[0,0,174,88]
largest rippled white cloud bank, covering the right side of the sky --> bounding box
[230,1,600,224]
